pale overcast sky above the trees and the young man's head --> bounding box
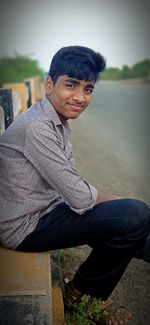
[0,0,150,70]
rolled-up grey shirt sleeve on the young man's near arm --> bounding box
[24,121,98,214]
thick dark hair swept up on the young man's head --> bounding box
[48,46,105,83]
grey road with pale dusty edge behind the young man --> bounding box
[71,81,150,203]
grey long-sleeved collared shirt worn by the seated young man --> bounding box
[0,98,97,248]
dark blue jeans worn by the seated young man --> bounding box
[17,199,150,300]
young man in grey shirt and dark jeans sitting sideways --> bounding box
[0,46,150,324]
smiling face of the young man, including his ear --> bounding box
[46,75,94,119]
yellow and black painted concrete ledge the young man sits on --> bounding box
[0,247,53,325]
